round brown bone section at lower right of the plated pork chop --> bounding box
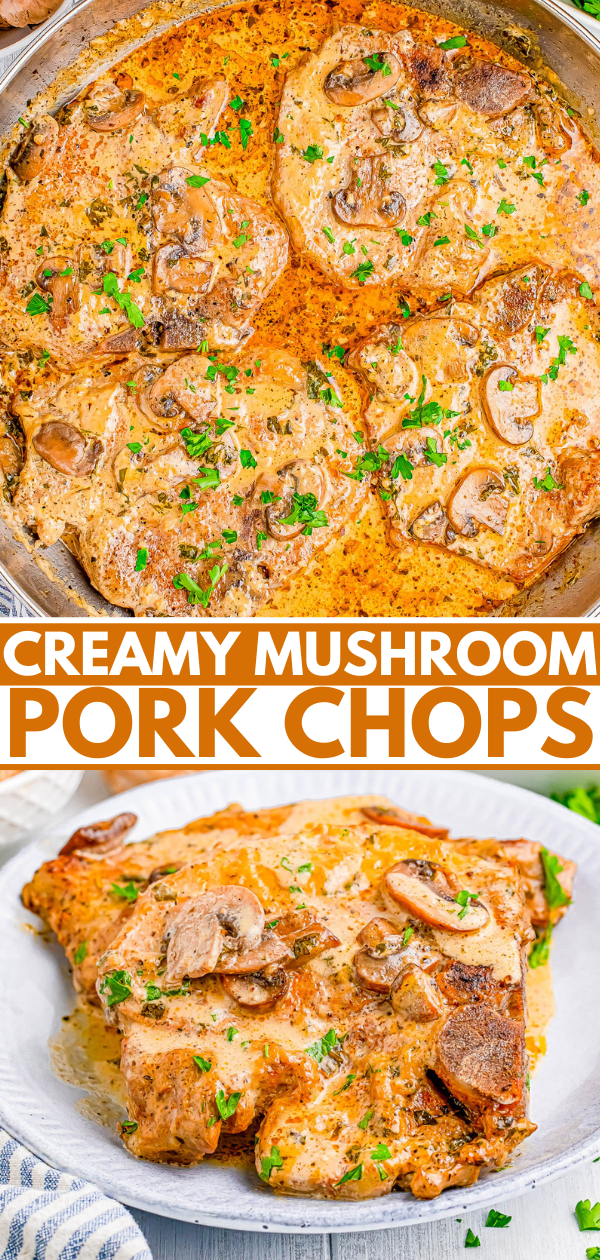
[436,1002,524,1106]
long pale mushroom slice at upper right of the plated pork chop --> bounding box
[382,859,489,932]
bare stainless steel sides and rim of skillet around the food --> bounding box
[0,0,600,617]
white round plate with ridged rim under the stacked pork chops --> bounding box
[0,767,600,1232]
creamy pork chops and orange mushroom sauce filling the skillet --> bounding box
[0,0,600,616]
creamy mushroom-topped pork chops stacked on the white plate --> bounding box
[23,796,575,1198]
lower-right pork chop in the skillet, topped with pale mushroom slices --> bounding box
[349,268,600,581]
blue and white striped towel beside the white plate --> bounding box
[0,1129,153,1260]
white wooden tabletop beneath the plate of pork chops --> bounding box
[0,771,600,1260]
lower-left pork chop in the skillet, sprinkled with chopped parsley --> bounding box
[14,344,369,616]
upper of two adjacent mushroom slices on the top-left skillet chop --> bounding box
[151,166,221,255]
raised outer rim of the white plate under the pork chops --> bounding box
[0,766,600,1234]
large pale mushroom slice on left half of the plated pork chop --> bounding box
[165,885,265,988]
